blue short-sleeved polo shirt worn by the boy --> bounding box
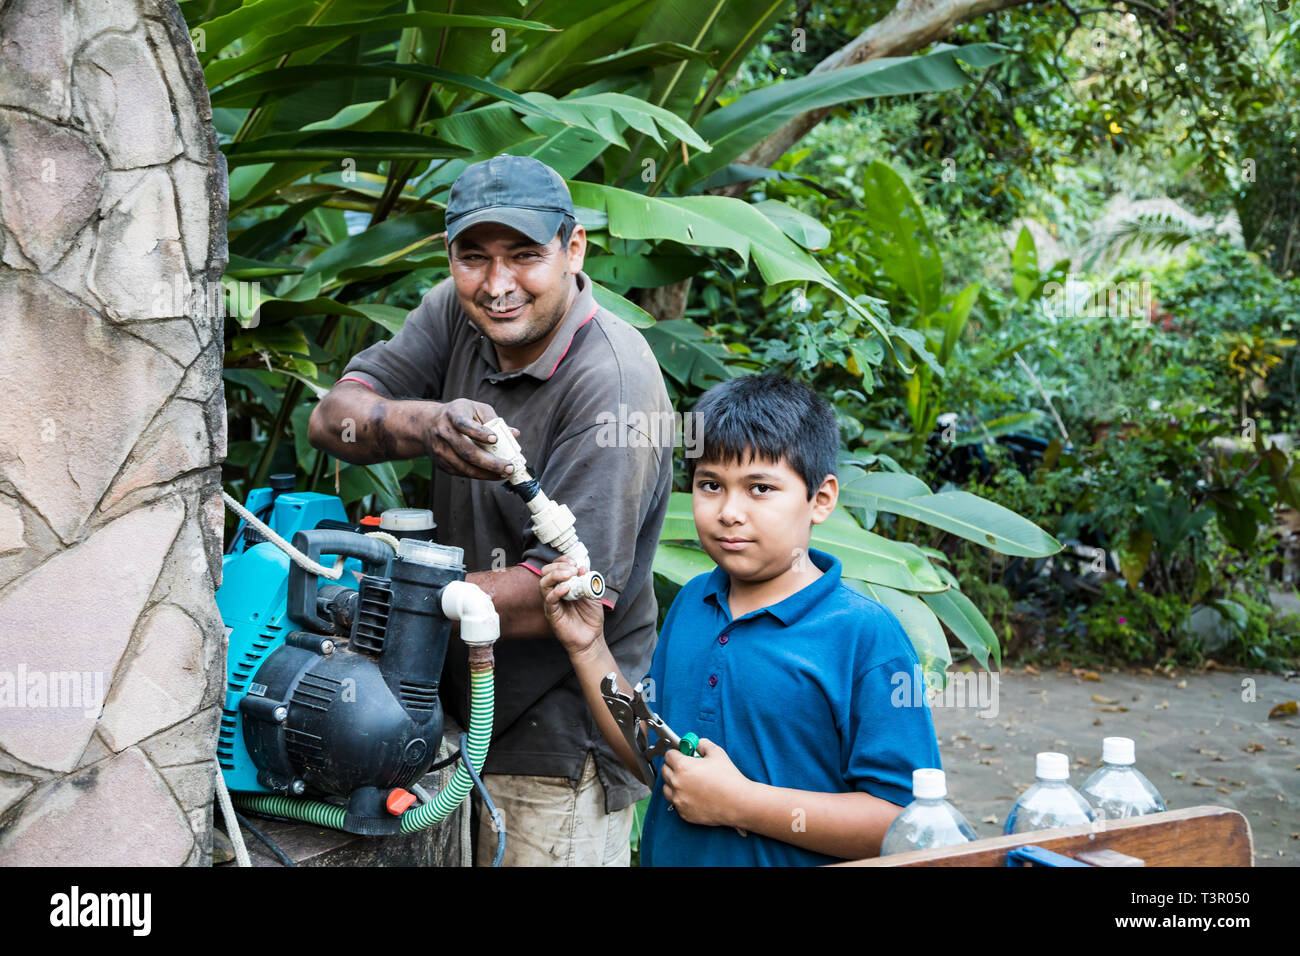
[641,549,940,866]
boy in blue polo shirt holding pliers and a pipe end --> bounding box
[541,375,940,866]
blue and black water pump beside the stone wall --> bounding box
[217,489,498,835]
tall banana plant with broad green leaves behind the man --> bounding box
[188,0,1002,515]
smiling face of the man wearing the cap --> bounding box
[449,222,586,349]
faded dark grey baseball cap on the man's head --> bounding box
[447,155,576,246]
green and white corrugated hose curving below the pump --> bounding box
[230,648,495,834]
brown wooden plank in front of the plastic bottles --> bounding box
[836,806,1255,866]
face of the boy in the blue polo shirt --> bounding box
[690,455,839,584]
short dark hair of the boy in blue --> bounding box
[686,372,840,501]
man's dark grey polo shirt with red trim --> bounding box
[339,273,672,812]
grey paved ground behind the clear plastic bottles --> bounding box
[932,667,1300,866]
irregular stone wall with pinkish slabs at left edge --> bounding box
[0,0,228,865]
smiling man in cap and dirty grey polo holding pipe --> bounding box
[308,156,672,865]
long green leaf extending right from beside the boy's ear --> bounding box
[840,472,1061,558]
